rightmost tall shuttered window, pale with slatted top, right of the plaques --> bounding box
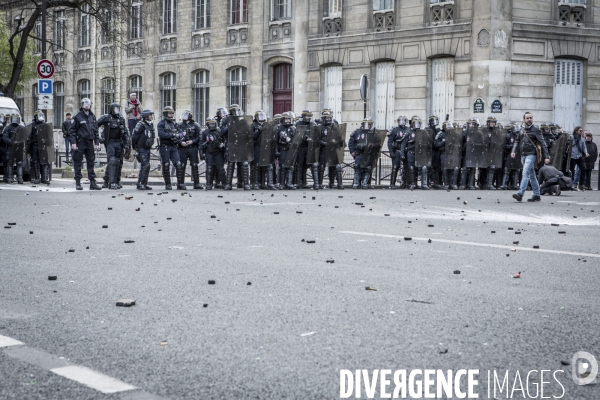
[554,59,583,132]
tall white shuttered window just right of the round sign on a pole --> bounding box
[374,61,396,129]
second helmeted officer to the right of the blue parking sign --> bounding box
[98,103,131,190]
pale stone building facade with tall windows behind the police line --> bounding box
[10,0,600,132]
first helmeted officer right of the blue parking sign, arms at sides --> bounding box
[69,97,102,190]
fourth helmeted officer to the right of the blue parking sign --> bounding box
[157,106,186,190]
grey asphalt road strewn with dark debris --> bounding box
[0,180,600,399]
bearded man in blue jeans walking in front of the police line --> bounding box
[510,112,550,201]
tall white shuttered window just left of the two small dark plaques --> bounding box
[430,57,454,121]
